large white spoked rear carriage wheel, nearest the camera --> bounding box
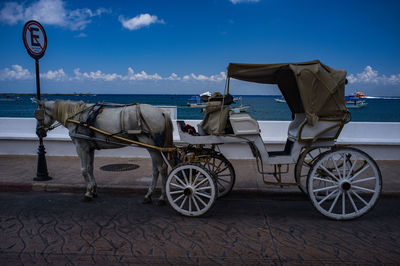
[307,147,382,220]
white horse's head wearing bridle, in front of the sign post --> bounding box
[31,98,55,137]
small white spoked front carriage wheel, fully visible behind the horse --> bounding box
[166,163,217,216]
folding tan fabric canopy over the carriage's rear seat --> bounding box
[228,60,347,124]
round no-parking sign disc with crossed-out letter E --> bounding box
[22,20,47,60]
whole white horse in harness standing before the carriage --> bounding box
[34,100,173,205]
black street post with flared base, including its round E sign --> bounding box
[22,20,51,181]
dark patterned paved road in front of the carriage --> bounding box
[0,193,400,265]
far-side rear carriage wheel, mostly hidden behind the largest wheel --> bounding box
[294,147,330,195]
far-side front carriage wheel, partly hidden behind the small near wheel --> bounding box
[196,153,236,198]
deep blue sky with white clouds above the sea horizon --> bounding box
[0,0,400,96]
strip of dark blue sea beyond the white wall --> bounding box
[0,94,400,122]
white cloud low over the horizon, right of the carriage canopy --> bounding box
[347,66,400,84]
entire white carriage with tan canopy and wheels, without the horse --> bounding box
[166,60,382,220]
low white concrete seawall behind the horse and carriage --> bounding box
[0,117,400,160]
